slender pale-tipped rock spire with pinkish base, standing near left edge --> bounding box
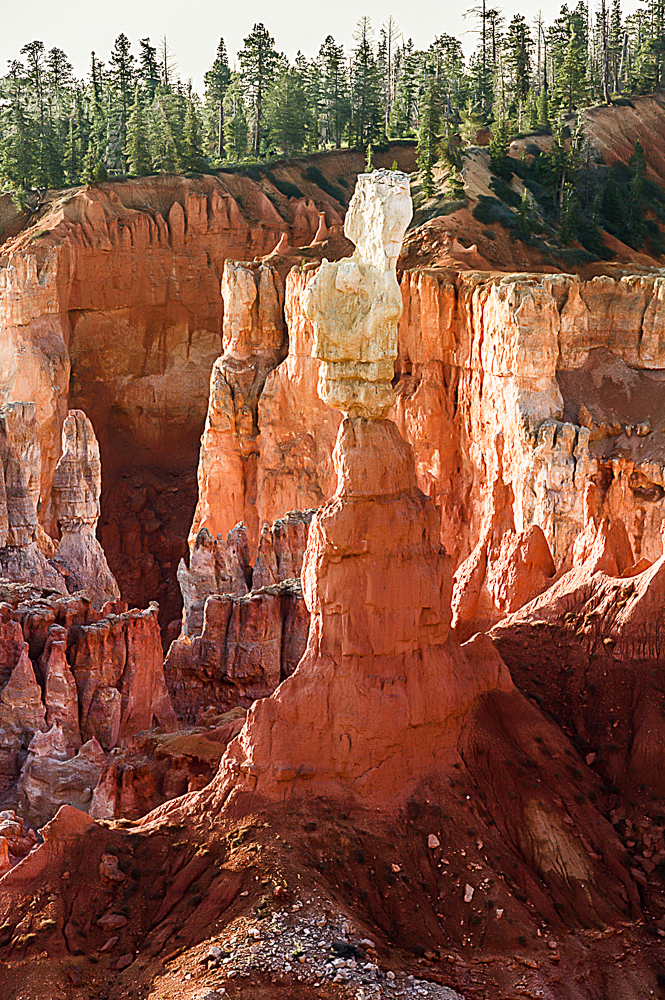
[51,410,120,608]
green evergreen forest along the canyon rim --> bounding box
[0,0,665,254]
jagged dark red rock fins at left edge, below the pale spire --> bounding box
[0,580,176,825]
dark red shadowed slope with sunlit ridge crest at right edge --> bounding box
[490,519,665,800]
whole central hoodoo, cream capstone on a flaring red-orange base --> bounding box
[218,170,512,798]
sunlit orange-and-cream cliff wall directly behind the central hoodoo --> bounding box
[191,269,665,610]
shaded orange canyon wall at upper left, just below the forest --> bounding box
[0,144,415,625]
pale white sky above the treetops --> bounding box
[0,0,638,91]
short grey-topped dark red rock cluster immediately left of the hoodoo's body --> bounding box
[170,510,314,722]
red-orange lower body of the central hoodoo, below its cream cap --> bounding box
[219,418,511,798]
